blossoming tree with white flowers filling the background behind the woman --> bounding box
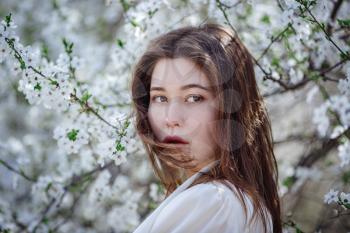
[0,0,350,232]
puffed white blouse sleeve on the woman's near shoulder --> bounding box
[151,183,270,233]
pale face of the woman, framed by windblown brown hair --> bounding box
[148,58,217,176]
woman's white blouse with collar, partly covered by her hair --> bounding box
[133,160,273,233]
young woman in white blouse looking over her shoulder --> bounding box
[131,23,282,233]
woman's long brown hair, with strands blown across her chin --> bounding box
[130,23,282,233]
